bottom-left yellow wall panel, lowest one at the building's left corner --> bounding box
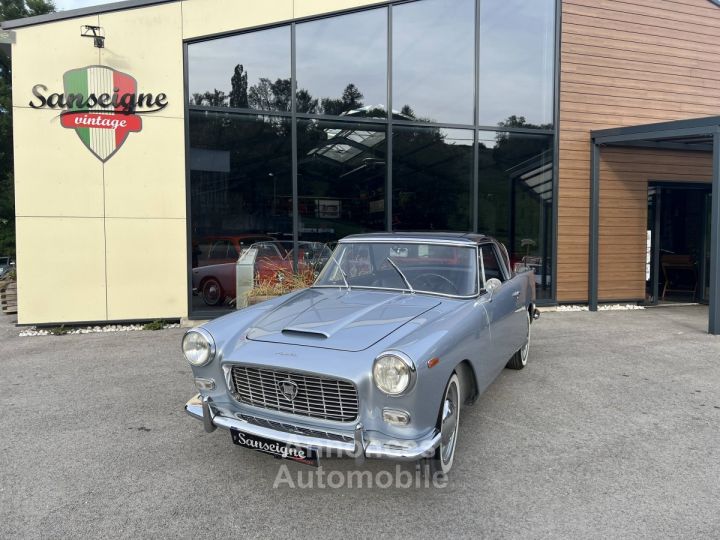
[17,217,106,324]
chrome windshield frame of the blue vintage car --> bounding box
[310,237,483,300]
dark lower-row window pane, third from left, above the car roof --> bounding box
[393,126,473,231]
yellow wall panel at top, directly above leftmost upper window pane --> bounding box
[182,0,293,39]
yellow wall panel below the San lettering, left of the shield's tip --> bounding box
[13,107,103,217]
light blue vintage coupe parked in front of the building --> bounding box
[182,233,538,474]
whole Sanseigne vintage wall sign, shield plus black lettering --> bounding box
[30,66,167,162]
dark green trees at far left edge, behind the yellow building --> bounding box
[0,0,55,256]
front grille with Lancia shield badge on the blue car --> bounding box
[231,366,358,422]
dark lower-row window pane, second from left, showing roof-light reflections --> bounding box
[298,120,387,242]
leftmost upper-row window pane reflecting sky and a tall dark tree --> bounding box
[188,26,291,111]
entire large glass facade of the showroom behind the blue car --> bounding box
[187,0,557,317]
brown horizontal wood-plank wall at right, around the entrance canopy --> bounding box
[557,0,720,302]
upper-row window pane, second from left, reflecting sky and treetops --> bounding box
[295,8,387,117]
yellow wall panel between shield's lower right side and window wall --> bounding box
[105,115,185,219]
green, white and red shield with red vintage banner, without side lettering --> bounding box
[60,66,142,163]
